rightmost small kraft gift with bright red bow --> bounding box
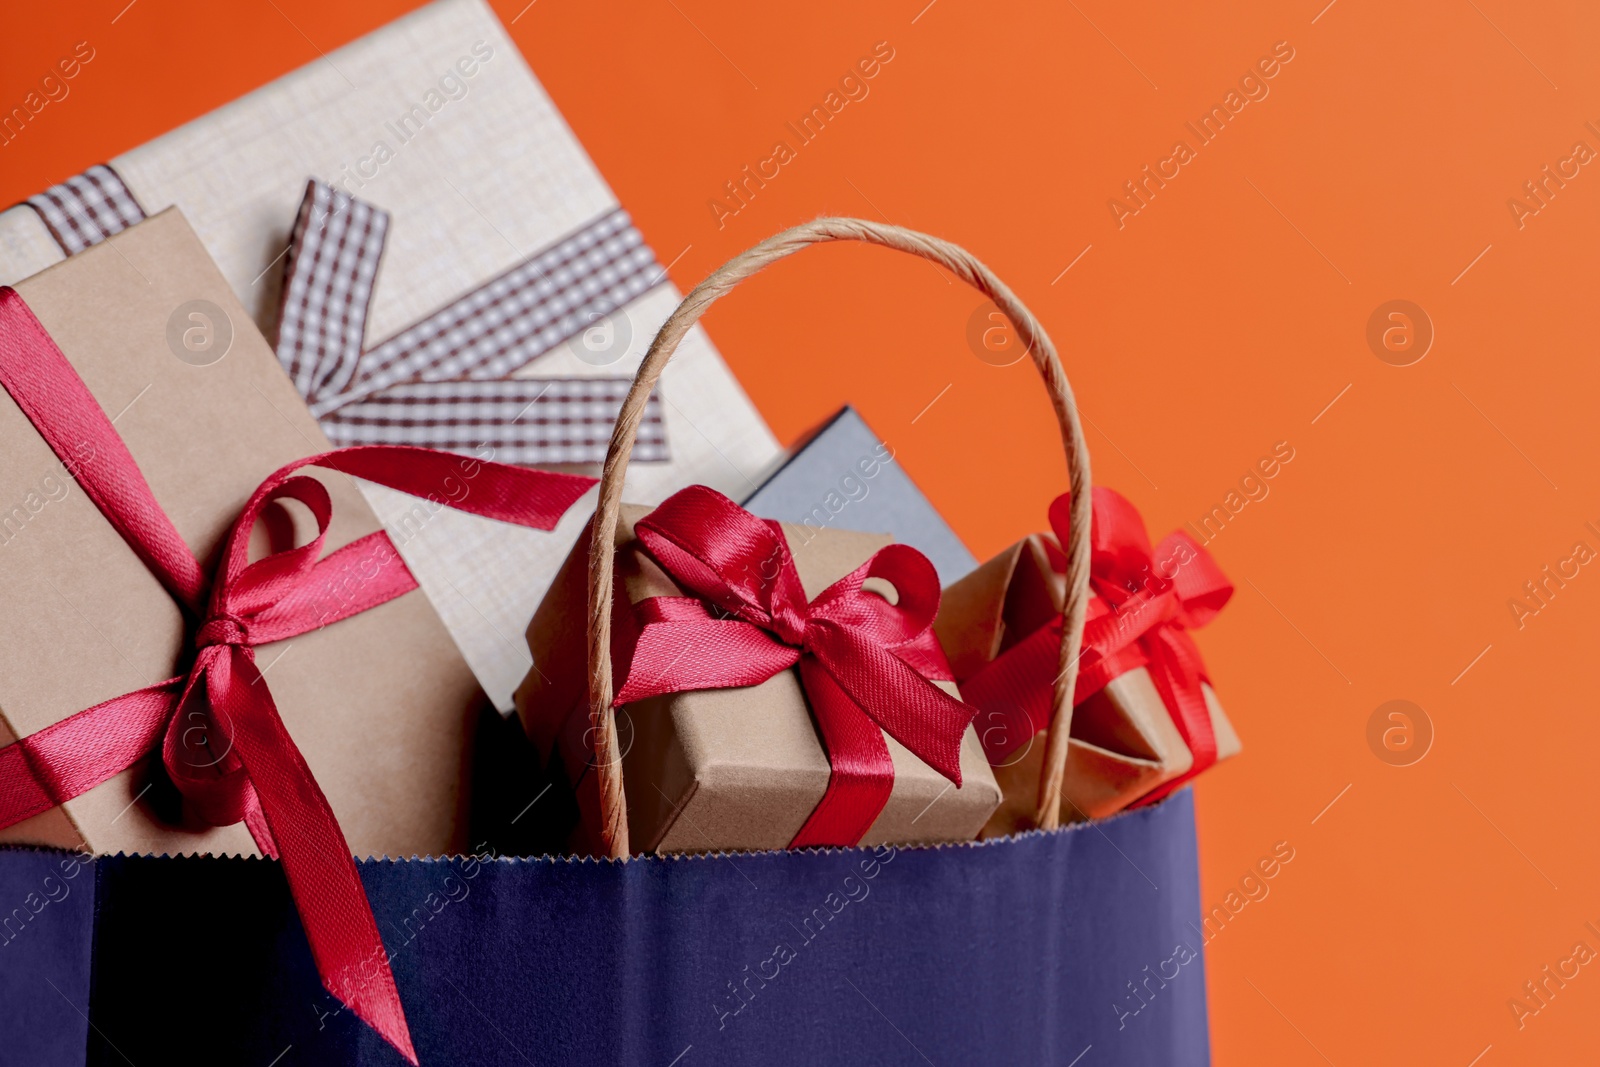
[934,486,1240,835]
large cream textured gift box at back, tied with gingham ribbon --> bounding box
[0,0,778,712]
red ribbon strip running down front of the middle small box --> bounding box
[789,656,894,848]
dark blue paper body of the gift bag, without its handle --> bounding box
[0,790,1210,1067]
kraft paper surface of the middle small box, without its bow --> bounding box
[517,495,1000,854]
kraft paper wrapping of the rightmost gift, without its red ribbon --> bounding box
[934,490,1242,837]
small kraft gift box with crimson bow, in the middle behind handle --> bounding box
[517,486,1000,854]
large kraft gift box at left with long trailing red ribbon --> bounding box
[0,210,592,1061]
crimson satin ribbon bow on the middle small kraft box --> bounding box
[614,485,971,848]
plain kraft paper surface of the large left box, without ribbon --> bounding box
[0,210,483,856]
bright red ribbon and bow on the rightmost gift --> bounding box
[960,488,1234,803]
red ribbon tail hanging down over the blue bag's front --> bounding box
[206,648,418,1064]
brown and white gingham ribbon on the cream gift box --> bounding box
[27,165,669,466]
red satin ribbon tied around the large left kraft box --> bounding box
[0,288,594,1064]
